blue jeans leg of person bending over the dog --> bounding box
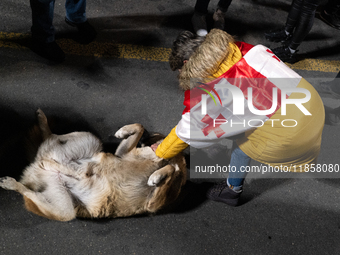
[227,142,251,190]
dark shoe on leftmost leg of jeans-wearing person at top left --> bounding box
[31,39,65,63]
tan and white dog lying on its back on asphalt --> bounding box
[0,109,186,221]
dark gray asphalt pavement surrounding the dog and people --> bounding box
[0,0,340,255]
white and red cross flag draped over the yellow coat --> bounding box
[176,43,302,148]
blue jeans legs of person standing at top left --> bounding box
[30,0,86,42]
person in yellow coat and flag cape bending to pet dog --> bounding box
[153,29,325,206]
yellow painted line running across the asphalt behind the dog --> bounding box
[0,32,340,73]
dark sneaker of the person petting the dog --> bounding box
[207,180,242,206]
